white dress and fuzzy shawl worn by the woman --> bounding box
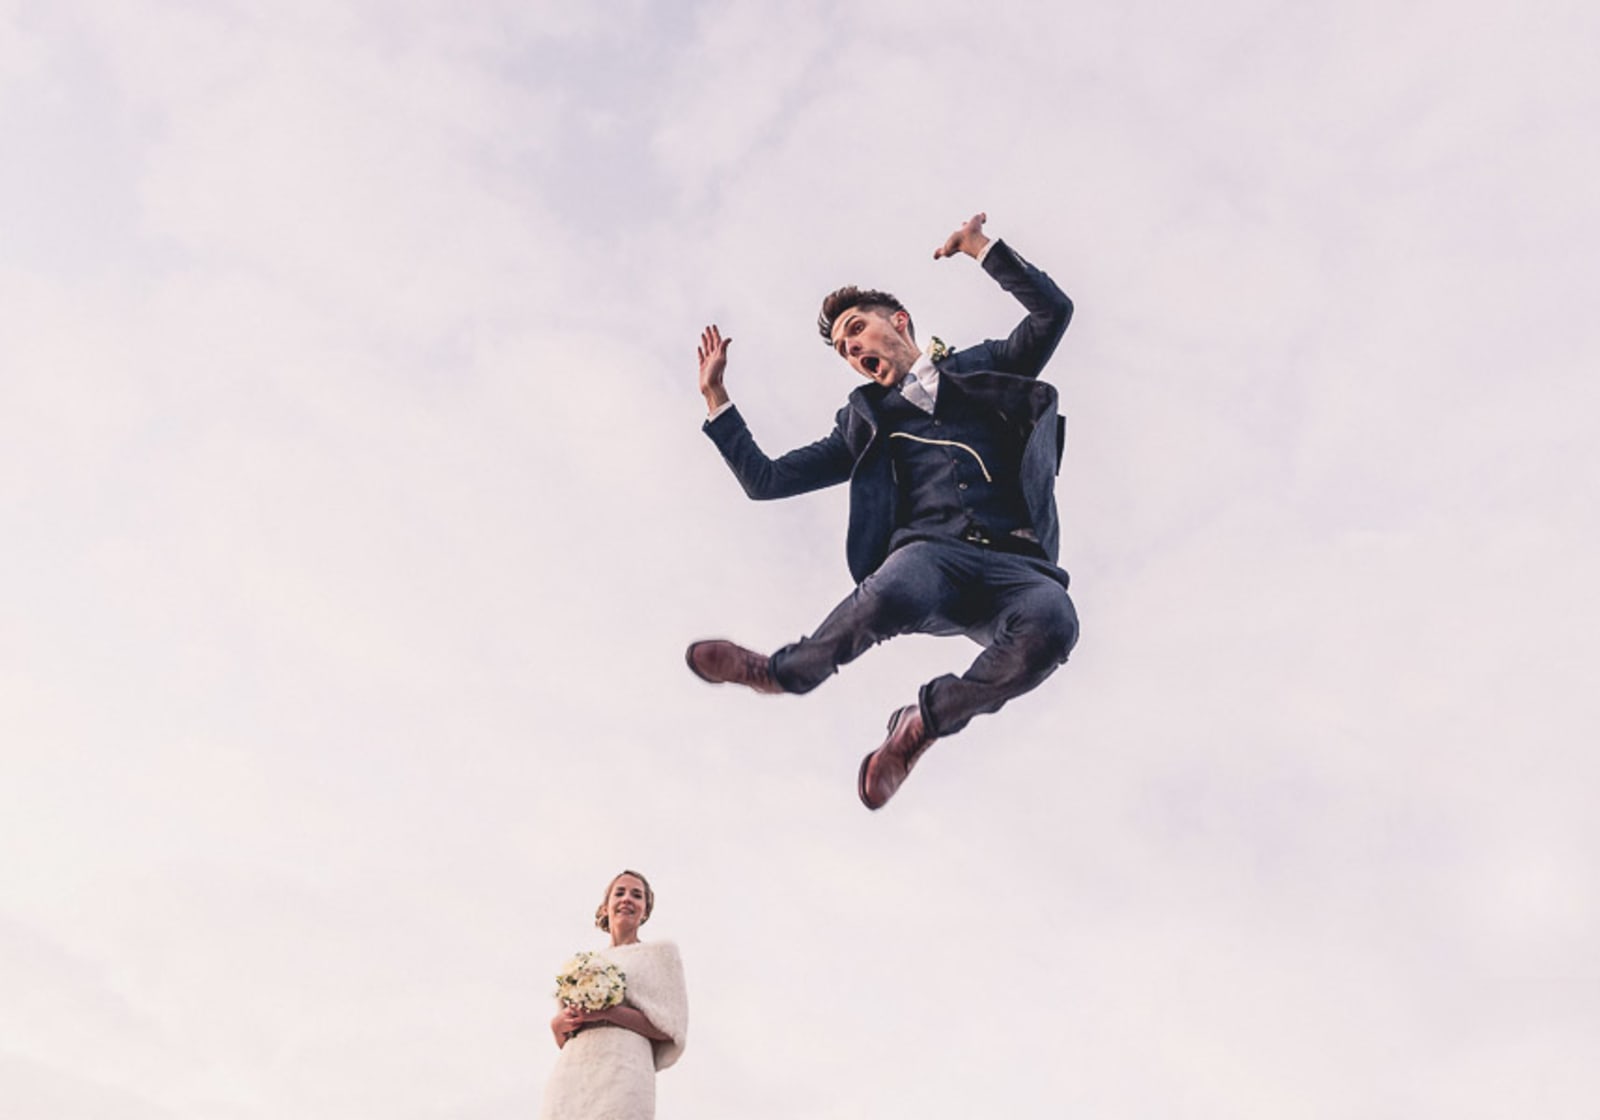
[539,941,690,1120]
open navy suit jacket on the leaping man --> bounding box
[706,240,1072,584]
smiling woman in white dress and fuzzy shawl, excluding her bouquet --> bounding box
[539,870,688,1120]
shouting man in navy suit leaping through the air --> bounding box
[686,214,1078,810]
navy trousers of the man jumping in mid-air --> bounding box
[771,539,1078,736]
